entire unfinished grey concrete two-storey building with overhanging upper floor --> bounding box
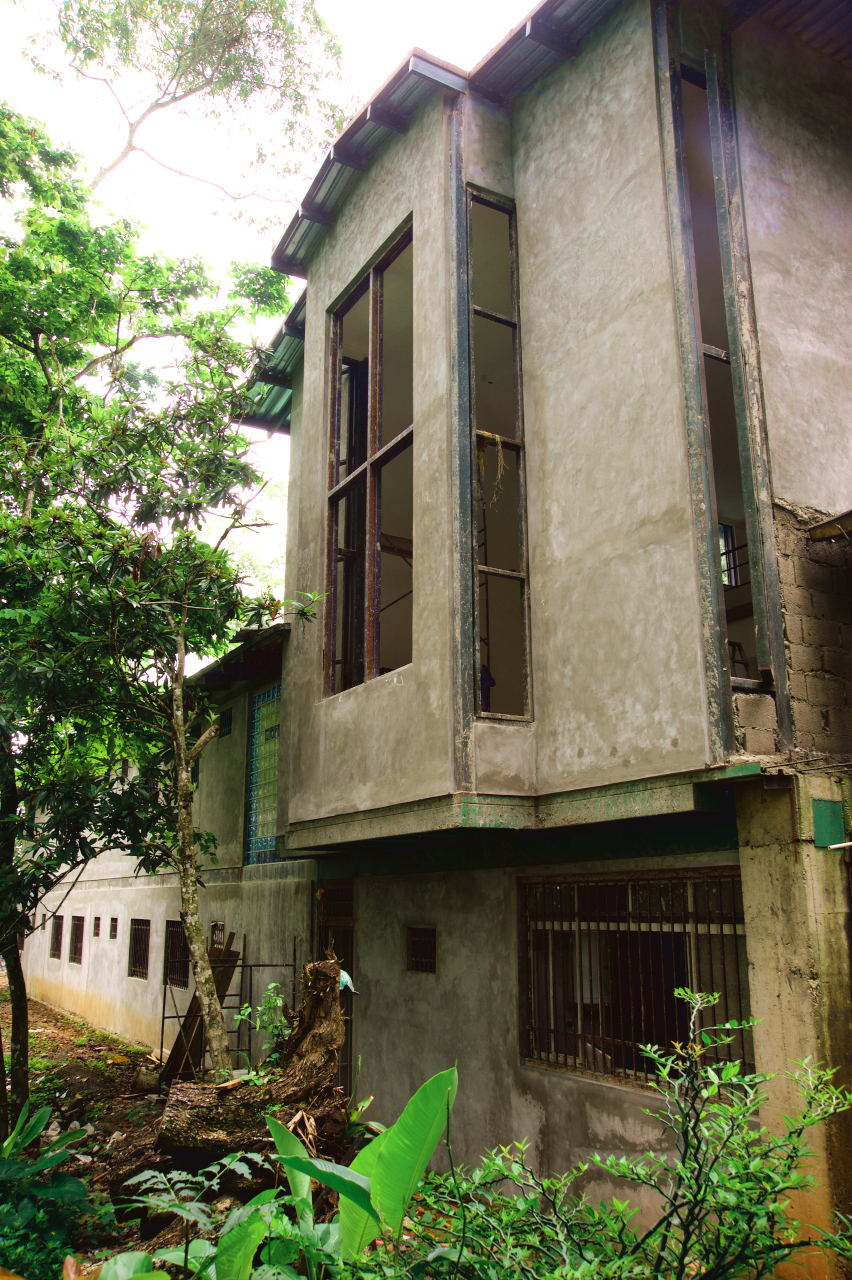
[26,0,852,1249]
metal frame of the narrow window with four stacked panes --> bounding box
[466,186,532,722]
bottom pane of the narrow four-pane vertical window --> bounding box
[480,573,525,716]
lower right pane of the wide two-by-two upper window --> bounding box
[379,445,414,675]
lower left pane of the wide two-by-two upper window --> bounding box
[331,479,367,692]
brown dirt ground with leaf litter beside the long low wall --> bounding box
[0,972,165,1261]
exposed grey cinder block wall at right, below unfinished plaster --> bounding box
[775,502,852,754]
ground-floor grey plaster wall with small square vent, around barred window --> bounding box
[353,849,736,1208]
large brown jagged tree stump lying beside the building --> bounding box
[156,957,345,1160]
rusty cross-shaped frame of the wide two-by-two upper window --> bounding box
[324,227,414,696]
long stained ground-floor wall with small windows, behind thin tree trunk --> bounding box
[23,861,313,1065]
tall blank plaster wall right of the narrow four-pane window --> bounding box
[514,3,706,792]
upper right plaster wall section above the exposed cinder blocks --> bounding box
[734,20,852,513]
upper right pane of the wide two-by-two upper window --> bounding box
[379,244,414,444]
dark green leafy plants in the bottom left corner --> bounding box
[0,1103,99,1280]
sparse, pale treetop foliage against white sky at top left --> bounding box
[23,0,340,198]
